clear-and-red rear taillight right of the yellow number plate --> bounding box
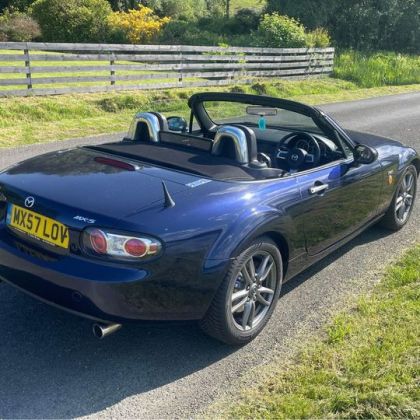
[83,228,162,259]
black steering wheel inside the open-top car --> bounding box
[277,131,321,169]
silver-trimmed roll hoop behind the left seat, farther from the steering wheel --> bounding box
[126,112,168,143]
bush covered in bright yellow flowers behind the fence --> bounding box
[108,5,170,44]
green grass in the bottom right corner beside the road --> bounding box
[212,245,420,419]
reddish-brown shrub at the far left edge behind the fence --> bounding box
[0,9,41,42]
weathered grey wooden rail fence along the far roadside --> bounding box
[0,42,334,97]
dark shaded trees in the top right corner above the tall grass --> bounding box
[267,0,420,52]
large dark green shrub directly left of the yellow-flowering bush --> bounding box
[31,0,111,42]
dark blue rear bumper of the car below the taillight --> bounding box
[0,224,226,322]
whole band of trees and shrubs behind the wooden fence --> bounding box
[0,0,420,54]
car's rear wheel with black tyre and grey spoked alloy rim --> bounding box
[200,237,283,345]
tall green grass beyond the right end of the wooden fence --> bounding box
[333,51,420,87]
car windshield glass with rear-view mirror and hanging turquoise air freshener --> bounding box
[203,101,322,134]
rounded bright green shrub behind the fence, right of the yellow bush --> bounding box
[257,13,306,48]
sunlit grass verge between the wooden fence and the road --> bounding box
[0,78,420,147]
